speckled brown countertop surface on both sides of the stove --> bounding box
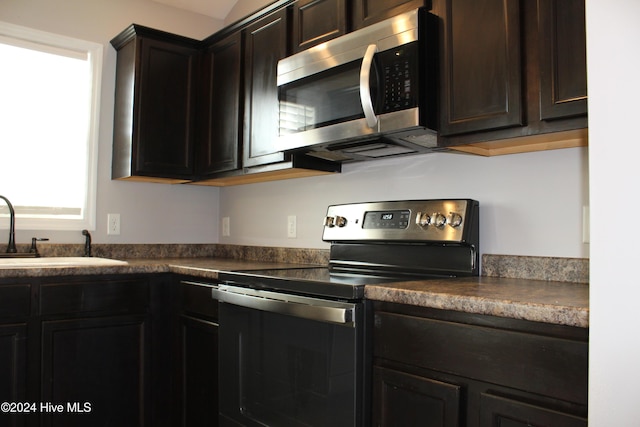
[0,257,589,328]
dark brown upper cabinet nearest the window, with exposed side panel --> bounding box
[111,24,198,182]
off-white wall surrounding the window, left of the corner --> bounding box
[0,0,223,243]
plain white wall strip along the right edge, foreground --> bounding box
[587,0,640,427]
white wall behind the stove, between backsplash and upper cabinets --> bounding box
[220,148,589,258]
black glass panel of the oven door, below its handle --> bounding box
[220,304,361,426]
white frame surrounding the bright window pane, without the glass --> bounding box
[0,21,103,230]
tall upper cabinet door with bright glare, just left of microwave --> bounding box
[243,9,287,166]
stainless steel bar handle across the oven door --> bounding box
[211,285,356,327]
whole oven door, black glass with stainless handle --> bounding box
[214,285,369,426]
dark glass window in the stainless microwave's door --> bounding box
[278,60,378,136]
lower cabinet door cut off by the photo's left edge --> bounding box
[0,324,26,427]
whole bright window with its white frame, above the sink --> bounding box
[0,22,102,230]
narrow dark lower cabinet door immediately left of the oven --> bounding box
[181,316,218,427]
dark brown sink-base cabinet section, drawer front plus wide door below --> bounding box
[37,276,153,427]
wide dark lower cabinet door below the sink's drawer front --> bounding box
[41,315,149,427]
